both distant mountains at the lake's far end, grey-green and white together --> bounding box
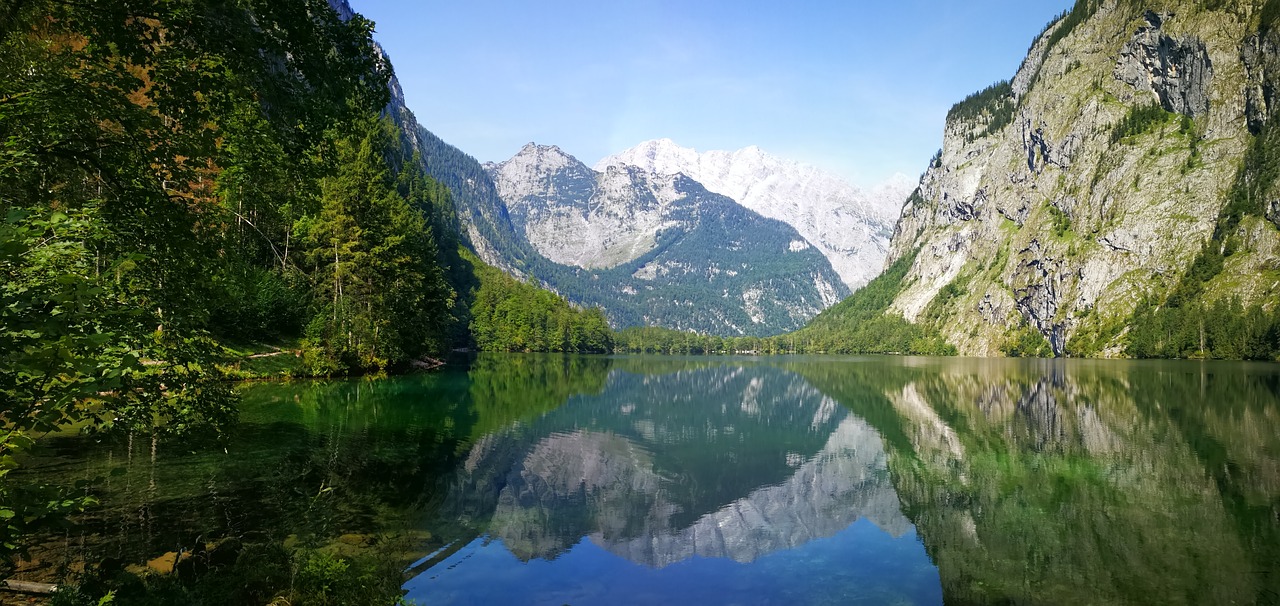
[428,140,908,336]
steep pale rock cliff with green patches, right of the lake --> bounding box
[888,0,1280,355]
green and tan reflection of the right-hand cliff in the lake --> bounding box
[800,360,1280,603]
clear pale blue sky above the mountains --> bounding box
[351,0,1073,186]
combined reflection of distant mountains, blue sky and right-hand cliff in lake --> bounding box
[407,357,1280,603]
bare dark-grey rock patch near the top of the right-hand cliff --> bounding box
[1115,12,1213,117]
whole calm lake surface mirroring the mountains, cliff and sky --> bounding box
[17,355,1280,605]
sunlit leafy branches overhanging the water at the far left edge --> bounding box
[0,208,233,555]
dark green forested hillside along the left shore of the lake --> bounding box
[0,0,609,586]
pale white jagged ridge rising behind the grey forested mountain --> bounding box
[595,138,914,288]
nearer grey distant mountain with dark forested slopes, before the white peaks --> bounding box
[465,145,847,336]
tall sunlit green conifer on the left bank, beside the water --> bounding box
[294,119,453,370]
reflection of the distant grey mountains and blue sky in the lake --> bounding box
[408,365,938,603]
